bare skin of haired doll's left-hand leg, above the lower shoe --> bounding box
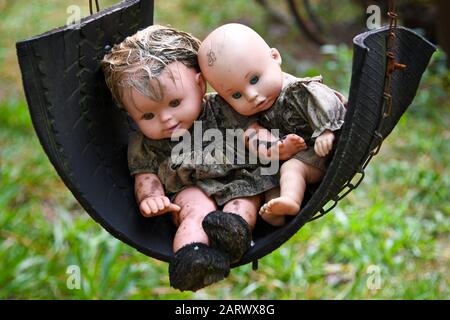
[173,187,217,252]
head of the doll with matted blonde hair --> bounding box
[102,25,206,140]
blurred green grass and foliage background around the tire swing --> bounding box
[0,0,450,299]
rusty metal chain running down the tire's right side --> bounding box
[309,0,406,221]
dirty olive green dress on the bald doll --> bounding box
[258,74,346,171]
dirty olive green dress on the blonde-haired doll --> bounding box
[128,94,279,205]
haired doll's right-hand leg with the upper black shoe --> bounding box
[203,195,261,263]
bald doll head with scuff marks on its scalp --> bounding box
[198,23,283,116]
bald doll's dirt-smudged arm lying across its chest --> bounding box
[245,122,306,160]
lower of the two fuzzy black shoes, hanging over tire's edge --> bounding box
[169,242,230,291]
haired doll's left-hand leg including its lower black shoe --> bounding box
[169,187,230,291]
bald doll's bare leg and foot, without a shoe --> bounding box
[260,159,324,223]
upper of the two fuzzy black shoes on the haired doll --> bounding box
[202,210,252,263]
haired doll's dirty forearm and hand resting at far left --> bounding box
[134,173,181,217]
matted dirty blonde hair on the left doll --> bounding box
[101,25,200,107]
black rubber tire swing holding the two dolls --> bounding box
[16,0,435,268]
